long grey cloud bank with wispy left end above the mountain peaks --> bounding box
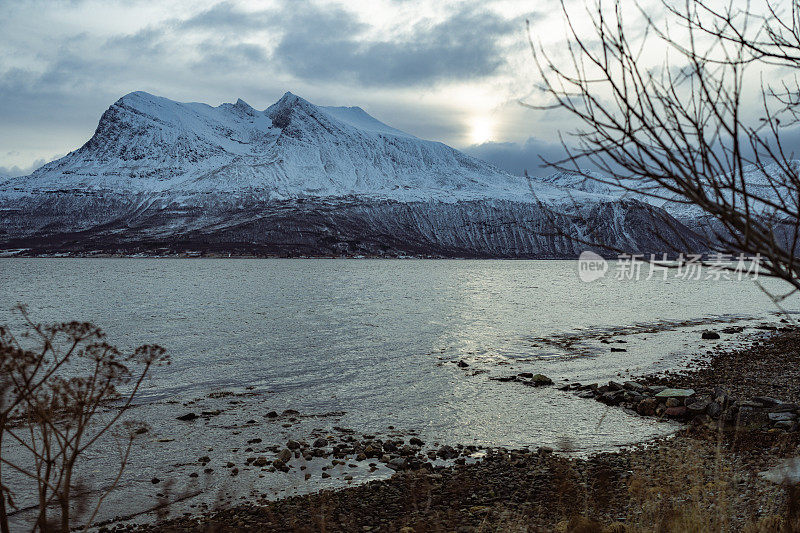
[73,0,524,87]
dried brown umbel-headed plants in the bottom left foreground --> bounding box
[0,306,167,533]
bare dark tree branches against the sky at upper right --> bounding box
[531,0,800,300]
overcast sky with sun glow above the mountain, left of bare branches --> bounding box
[0,0,792,179]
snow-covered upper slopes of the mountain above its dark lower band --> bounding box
[0,92,582,202]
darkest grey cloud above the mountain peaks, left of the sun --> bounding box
[274,4,522,86]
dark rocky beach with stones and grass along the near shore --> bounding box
[94,325,800,533]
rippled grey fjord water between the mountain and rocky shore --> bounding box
[0,258,800,525]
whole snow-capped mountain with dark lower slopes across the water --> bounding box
[0,92,702,257]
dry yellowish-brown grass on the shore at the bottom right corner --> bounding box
[454,424,800,533]
